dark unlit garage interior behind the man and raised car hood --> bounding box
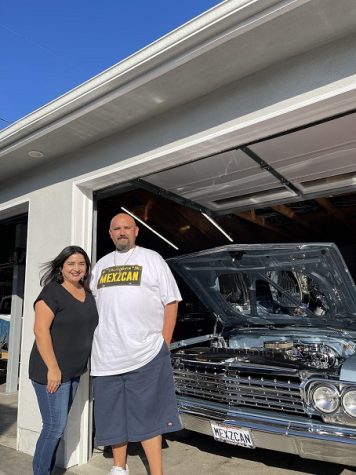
[96,184,356,340]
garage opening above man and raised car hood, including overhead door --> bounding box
[94,108,356,276]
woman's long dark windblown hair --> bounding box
[40,246,91,292]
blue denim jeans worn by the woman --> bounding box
[32,378,79,475]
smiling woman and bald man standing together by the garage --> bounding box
[29,213,181,475]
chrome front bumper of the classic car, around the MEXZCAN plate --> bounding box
[177,396,356,466]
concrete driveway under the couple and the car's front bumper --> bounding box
[0,386,356,475]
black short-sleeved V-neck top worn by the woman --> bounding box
[29,282,98,384]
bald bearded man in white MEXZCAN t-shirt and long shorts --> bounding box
[91,213,181,475]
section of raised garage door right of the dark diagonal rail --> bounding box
[249,114,356,196]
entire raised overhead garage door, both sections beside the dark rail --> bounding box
[144,113,356,212]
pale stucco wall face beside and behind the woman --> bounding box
[18,182,72,453]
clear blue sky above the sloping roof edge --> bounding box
[0,0,220,128]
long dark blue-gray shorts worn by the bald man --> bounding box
[93,342,182,446]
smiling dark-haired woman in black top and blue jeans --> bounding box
[29,246,98,475]
